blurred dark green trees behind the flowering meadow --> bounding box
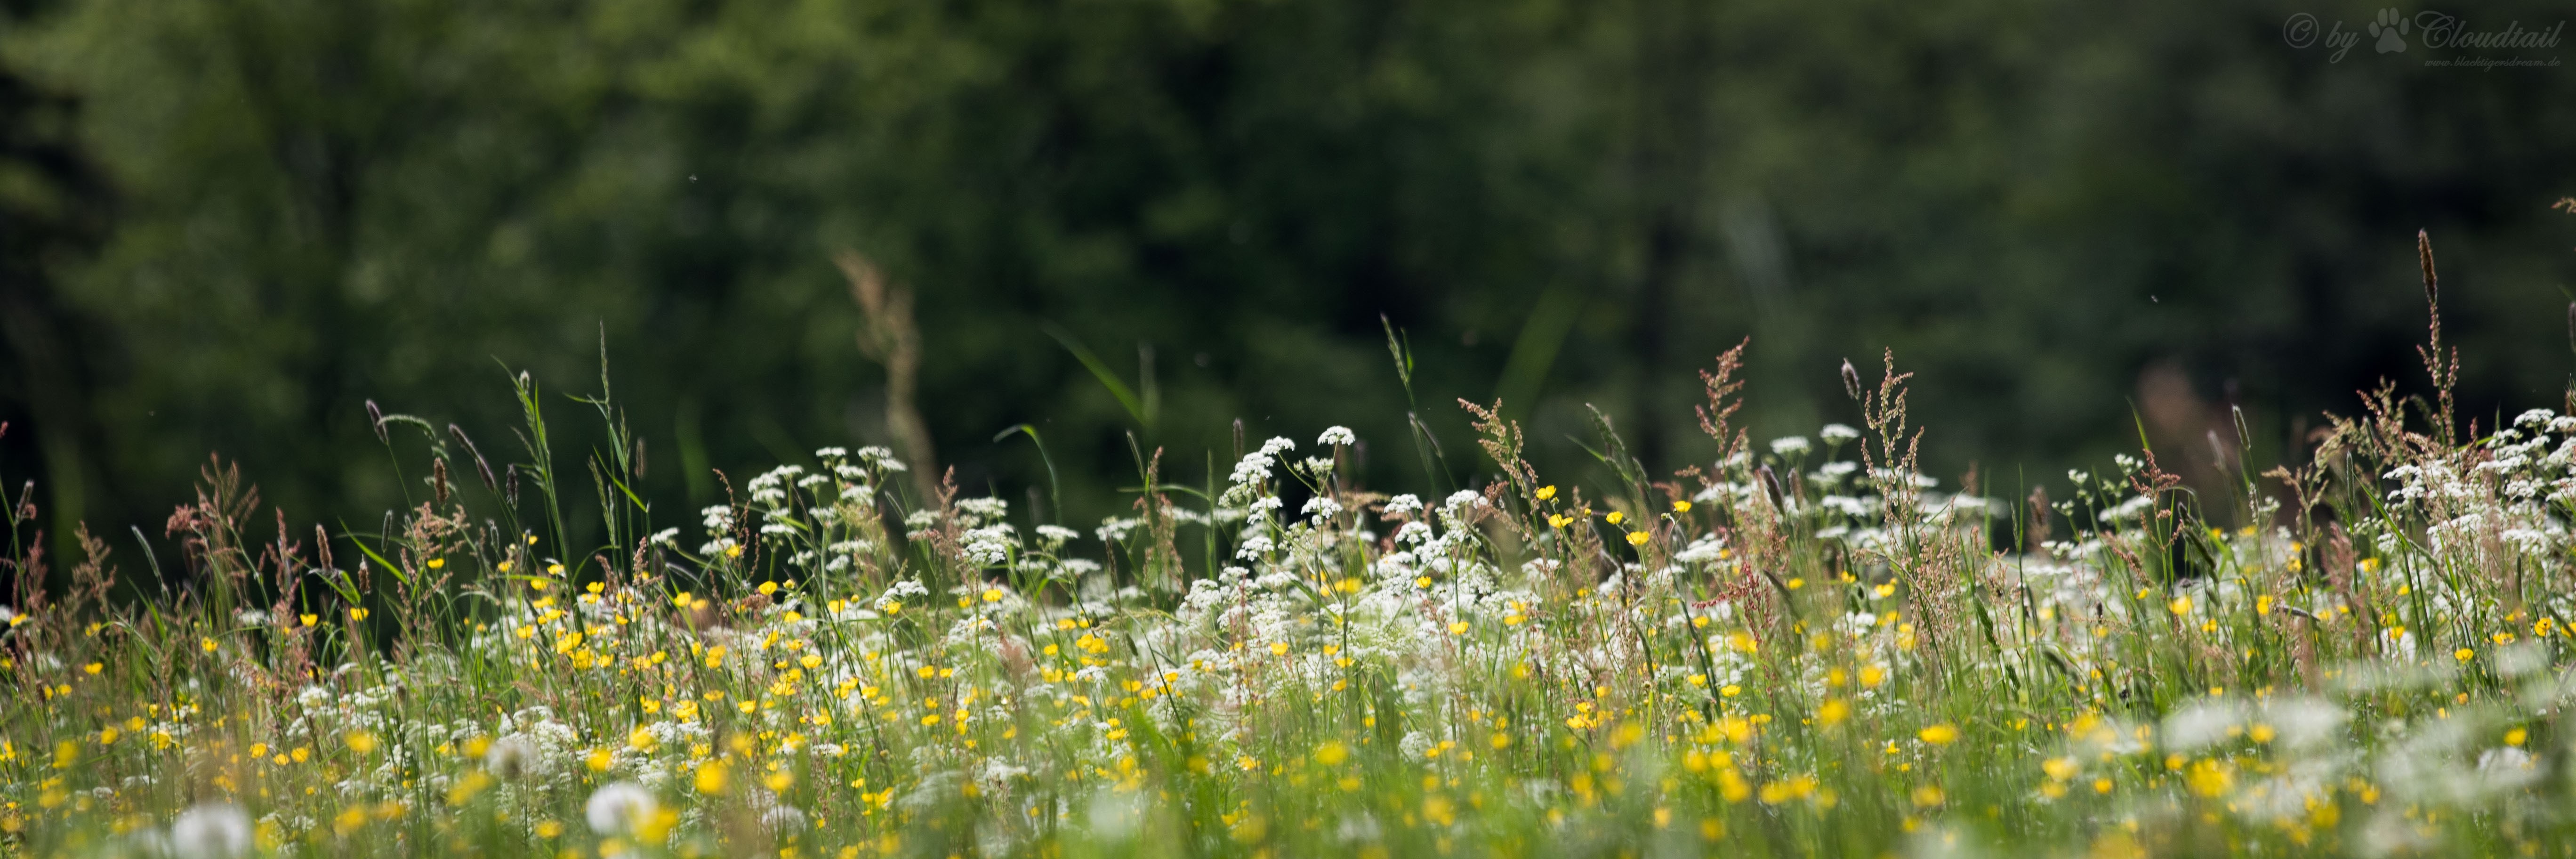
[0,0,2576,559]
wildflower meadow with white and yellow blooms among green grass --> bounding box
[0,251,2576,857]
